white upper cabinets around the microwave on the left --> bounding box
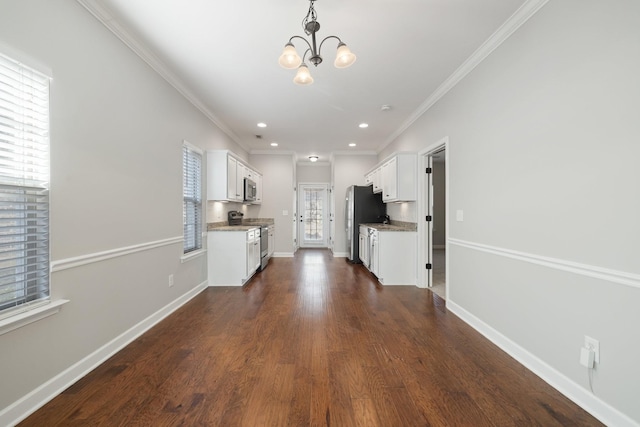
[207,150,262,203]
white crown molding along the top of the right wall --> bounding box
[378,0,549,152]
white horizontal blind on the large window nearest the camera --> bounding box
[0,54,49,317]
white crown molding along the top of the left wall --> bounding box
[77,0,249,151]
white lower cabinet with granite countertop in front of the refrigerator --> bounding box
[360,227,418,285]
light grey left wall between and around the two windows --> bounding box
[0,0,246,425]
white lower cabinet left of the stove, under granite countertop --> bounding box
[207,228,260,286]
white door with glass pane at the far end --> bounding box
[298,184,329,248]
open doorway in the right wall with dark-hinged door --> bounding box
[419,138,449,299]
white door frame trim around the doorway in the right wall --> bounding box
[417,136,451,290]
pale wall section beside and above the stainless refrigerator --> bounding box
[332,154,378,256]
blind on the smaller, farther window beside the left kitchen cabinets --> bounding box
[182,143,202,254]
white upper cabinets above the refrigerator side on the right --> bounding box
[365,153,418,203]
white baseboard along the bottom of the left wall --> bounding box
[0,282,207,426]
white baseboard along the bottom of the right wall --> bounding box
[447,299,638,427]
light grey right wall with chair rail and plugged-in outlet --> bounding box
[381,0,640,425]
